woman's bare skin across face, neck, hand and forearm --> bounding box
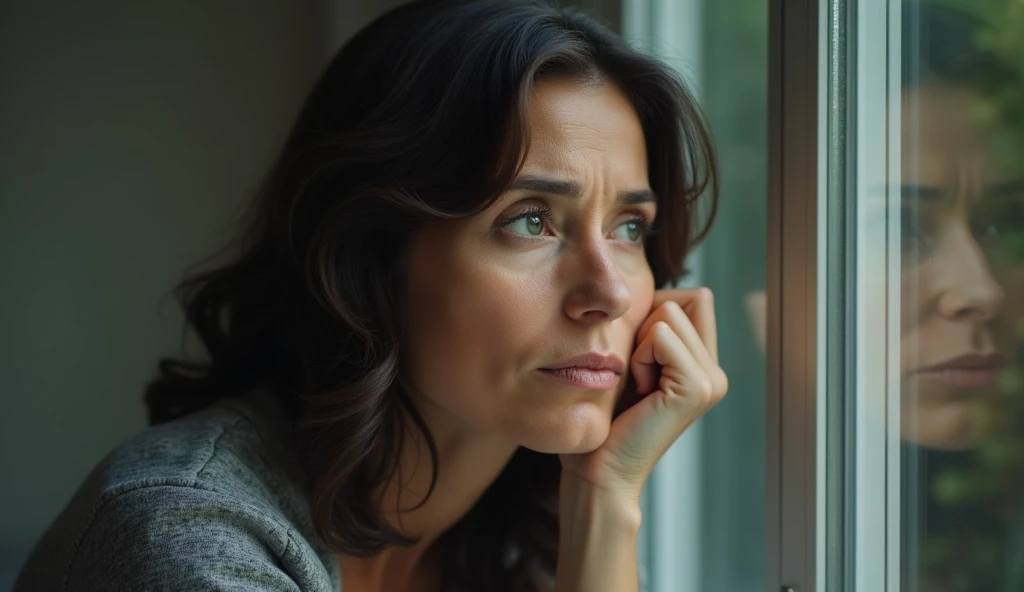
[339,79,727,592]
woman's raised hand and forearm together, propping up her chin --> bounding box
[555,288,728,592]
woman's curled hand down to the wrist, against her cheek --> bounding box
[561,288,728,502]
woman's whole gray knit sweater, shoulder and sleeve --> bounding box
[13,392,341,592]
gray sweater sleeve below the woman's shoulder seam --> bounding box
[63,484,328,592]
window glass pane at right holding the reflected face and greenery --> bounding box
[901,0,1024,592]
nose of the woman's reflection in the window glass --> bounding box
[938,232,1007,322]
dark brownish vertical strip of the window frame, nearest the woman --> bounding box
[765,0,827,592]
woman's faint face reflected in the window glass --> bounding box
[901,85,1024,449]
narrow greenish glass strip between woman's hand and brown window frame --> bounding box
[699,0,768,592]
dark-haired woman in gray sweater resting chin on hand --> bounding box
[9,0,726,592]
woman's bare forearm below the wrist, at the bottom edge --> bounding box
[555,476,640,592]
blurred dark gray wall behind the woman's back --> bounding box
[0,0,403,590]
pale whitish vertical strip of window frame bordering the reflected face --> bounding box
[845,0,902,592]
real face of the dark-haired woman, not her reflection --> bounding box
[404,75,656,453]
